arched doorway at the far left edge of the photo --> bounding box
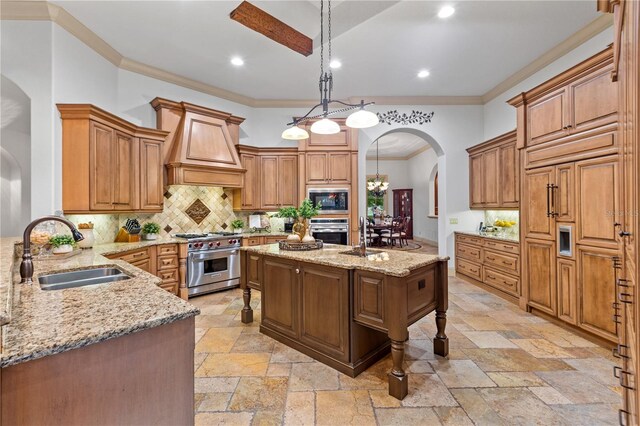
[0,76,31,237]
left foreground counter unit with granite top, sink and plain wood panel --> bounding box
[0,238,199,425]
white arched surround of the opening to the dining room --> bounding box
[358,126,447,256]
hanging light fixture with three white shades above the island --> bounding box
[282,0,379,140]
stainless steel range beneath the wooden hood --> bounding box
[175,232,242,296]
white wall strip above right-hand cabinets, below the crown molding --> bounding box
[483,27,613,140]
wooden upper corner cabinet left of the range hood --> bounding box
[58,104,167,213]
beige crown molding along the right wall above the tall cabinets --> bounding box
[481,14,613,104]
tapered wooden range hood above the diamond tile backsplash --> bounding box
[151,98,245,188]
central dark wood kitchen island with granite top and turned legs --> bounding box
[240,244,449,399]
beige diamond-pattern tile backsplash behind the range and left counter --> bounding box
[66,185,284,244]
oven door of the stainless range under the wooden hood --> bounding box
[187,249,240,287]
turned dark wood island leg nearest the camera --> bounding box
[385,277,409,400]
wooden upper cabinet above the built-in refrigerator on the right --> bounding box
[509,47,618,169]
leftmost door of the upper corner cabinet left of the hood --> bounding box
[89,121,115,210]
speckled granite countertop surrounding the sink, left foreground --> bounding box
[0,238,200,367]
